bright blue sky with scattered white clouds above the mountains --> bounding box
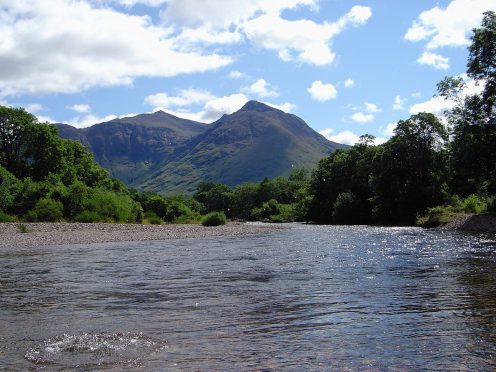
[0,0,496,144]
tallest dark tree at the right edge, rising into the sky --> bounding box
[438,12,496,197]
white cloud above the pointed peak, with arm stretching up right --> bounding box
[243,6,372,66]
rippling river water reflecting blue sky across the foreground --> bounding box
[0,225,496,371]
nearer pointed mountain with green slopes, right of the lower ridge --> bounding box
[137,101,345,192]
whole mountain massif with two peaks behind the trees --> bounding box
[58,101,346,193]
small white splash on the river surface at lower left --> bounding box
[24,333,166,368]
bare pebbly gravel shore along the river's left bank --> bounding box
[0,222,284,248]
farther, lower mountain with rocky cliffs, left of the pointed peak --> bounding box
[56,111,208,185]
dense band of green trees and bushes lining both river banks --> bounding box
[0,12,496,226]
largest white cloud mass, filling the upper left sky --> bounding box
[0,0,232,96]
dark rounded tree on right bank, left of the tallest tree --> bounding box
[371,113,448,225]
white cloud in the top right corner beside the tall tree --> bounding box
[404,0,496,49]
